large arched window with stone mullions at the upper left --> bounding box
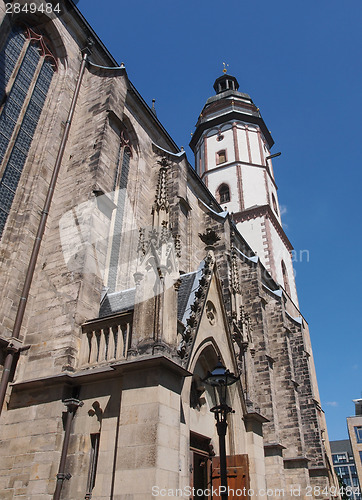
[0,27,57,238]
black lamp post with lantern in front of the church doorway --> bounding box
[203,359,240,500]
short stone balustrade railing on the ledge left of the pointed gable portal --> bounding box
[80,313,132,367]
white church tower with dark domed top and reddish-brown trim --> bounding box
[190,72,298,305]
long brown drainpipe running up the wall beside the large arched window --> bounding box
[0,40,92,415]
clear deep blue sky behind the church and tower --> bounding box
[78,0,362,440]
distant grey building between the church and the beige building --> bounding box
[330,439,362,500]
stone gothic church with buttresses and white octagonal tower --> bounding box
[0,0,336,500]
